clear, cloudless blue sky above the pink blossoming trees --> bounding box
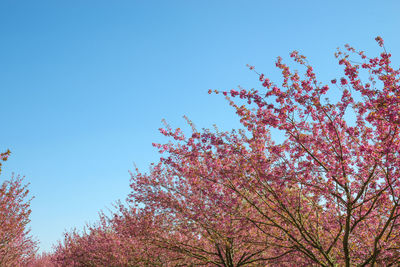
[0,0,400,251]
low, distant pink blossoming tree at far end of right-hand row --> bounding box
[51,204,184,266]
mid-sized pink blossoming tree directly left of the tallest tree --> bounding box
[130,126,285,266]
